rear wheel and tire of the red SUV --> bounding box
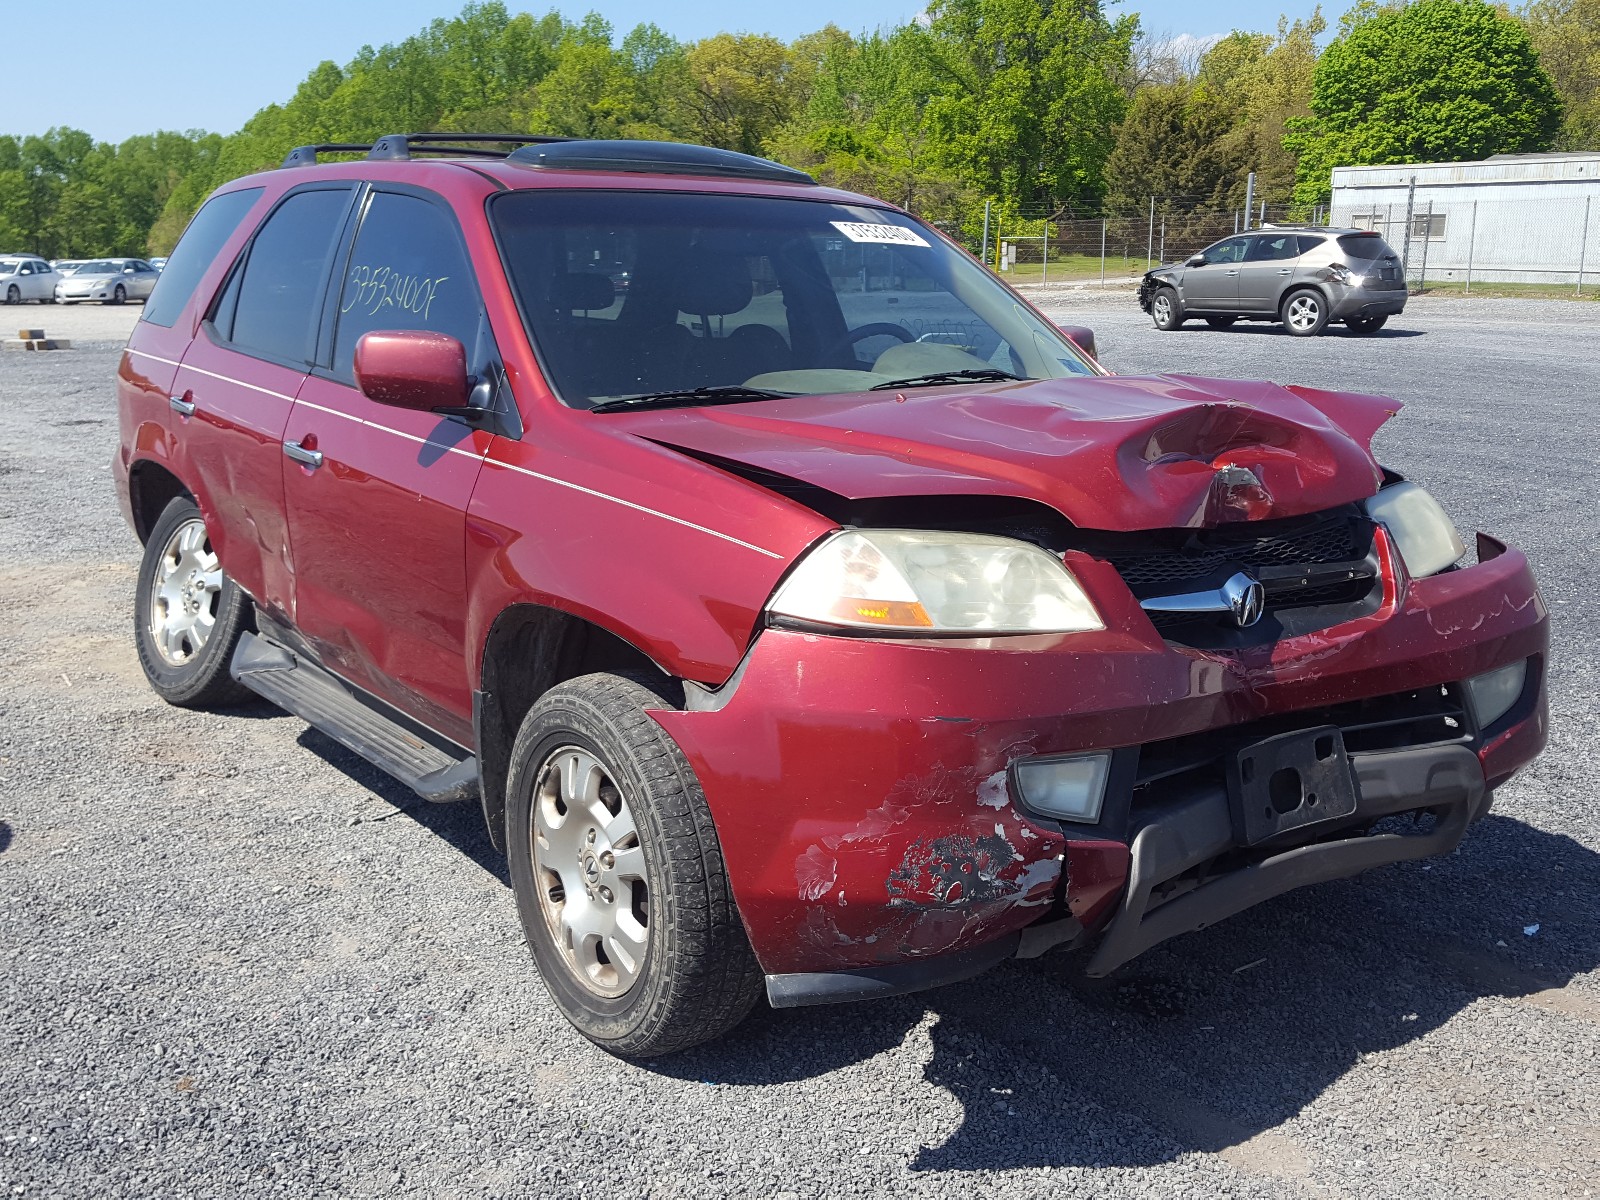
[133,496,253,709]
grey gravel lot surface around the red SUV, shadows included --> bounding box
[0,290,1600,1197]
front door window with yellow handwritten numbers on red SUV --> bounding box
[333,192,480,379]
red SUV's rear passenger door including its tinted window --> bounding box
[173,182,354,619]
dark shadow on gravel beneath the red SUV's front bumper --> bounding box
[645,816,1600,1171]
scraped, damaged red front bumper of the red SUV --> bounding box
[643,538,1547,1006]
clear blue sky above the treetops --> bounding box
[0,0,1318,142]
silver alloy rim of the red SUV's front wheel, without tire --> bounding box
[533,746,650,998]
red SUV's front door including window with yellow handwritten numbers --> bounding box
[285,184,498,746]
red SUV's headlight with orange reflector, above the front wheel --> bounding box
[766,530,1106,634]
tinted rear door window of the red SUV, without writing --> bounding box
[218,187,350,363]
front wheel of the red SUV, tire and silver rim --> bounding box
[506,674,763,1058]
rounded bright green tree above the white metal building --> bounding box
[1285,0,1562,203]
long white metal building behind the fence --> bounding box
[1330,152,1600,285]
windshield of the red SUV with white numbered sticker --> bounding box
[490,190,1094,408]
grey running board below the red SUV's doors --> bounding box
[229,634,478,805]
